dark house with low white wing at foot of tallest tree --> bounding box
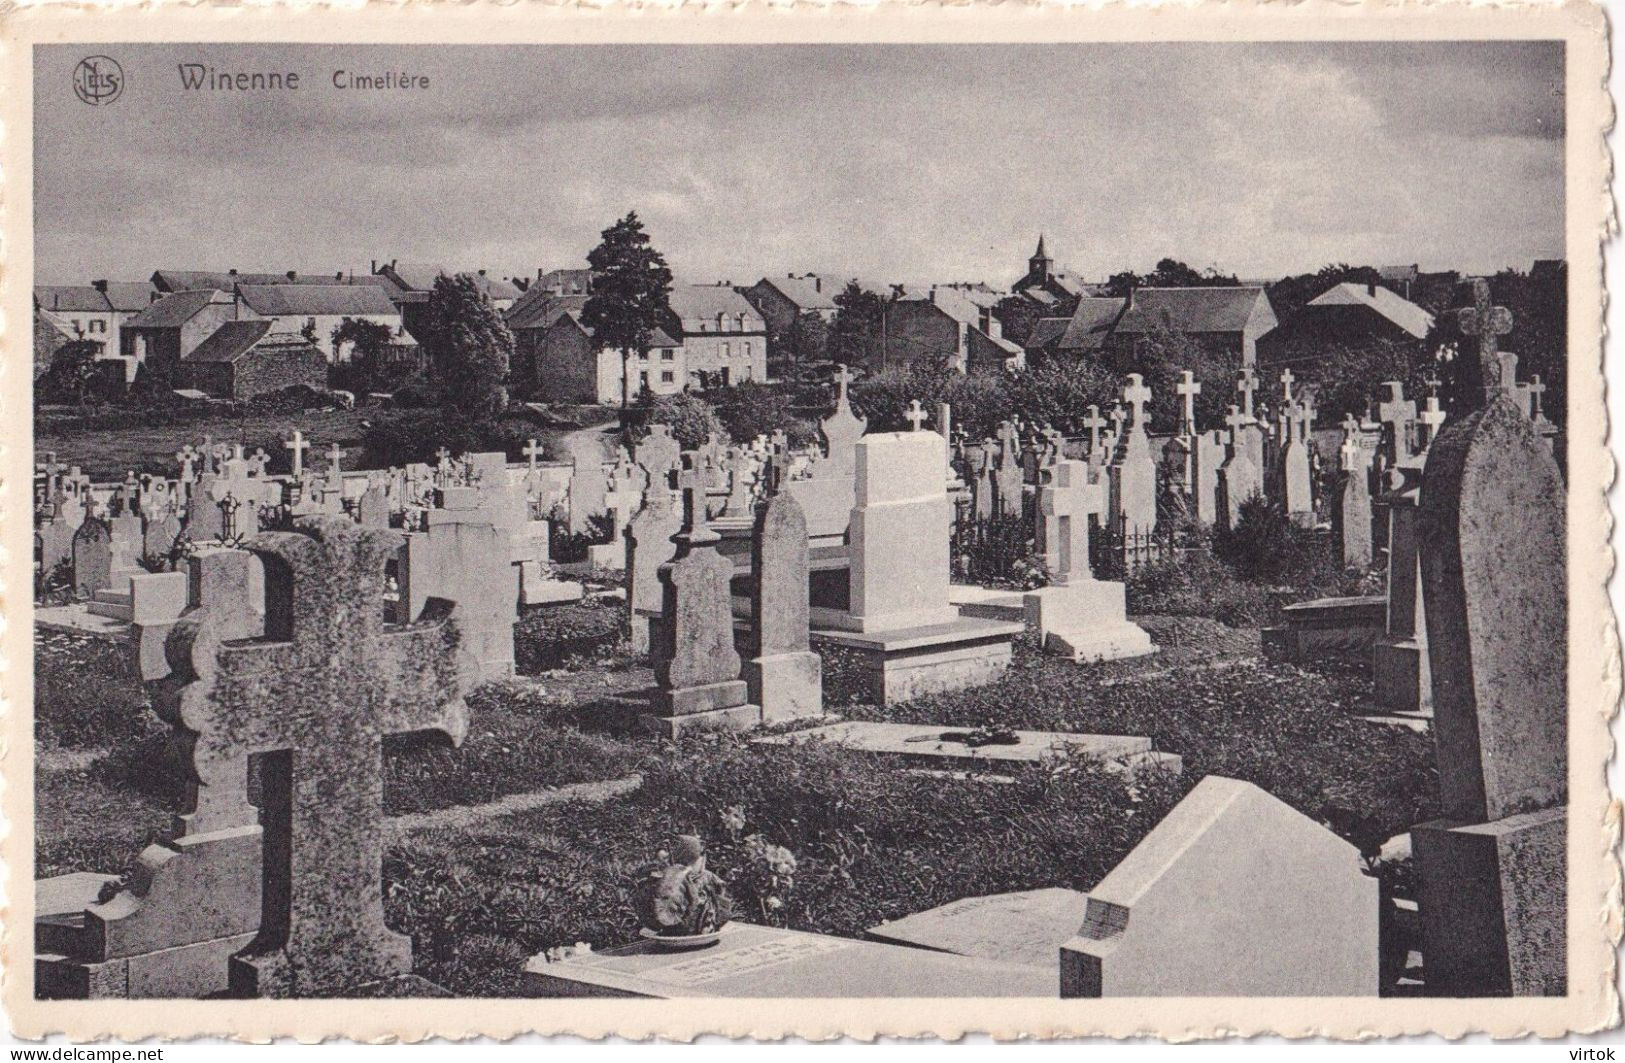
[507,294,689,406]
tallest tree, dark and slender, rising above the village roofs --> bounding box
[582,210,671,406]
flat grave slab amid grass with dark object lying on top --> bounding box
[756,720,1180,770]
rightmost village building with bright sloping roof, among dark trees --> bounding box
[1258,283,1433,369]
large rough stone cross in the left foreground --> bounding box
[166,515,468,996]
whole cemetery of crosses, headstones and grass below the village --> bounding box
[34,281,1567,1000]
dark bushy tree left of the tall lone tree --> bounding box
[419,273,514,421]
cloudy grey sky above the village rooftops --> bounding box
[34,42,1563,284]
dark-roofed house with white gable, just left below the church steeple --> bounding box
[881,286,1025,372]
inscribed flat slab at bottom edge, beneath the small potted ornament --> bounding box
[525,923,1060,1000]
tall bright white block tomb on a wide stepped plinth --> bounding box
[811,431,1022,704]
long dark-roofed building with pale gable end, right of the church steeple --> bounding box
[1103,286,1276,369]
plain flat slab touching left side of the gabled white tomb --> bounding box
[868,886,1089,970]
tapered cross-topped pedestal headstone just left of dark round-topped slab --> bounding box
[648,455,762,738]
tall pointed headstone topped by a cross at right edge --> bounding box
[1411,280,1568,996]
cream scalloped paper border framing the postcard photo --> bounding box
[0,0,1625,1042]
